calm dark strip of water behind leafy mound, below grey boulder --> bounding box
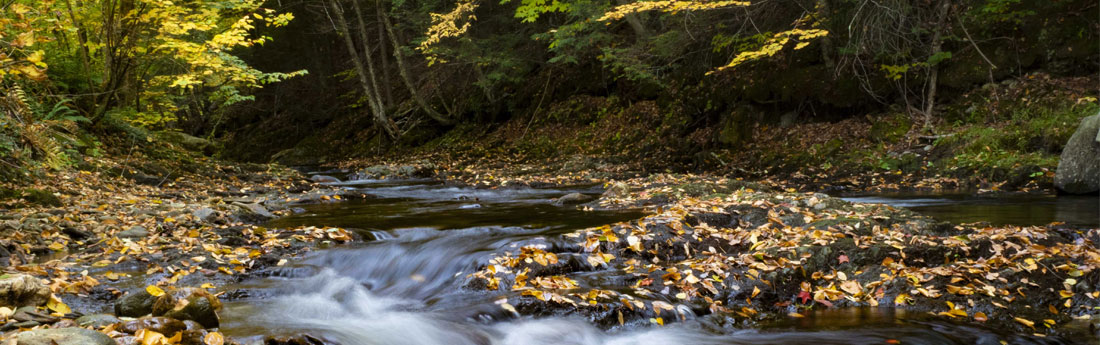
[843,193,1100,227]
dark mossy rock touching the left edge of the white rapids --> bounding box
[153,288,221,329]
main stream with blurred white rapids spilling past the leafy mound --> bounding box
[214,180,1091,345]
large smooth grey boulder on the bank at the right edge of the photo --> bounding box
[1054,115,1100,194]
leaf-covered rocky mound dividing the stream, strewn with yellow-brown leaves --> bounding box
[468,175,1100,335]
